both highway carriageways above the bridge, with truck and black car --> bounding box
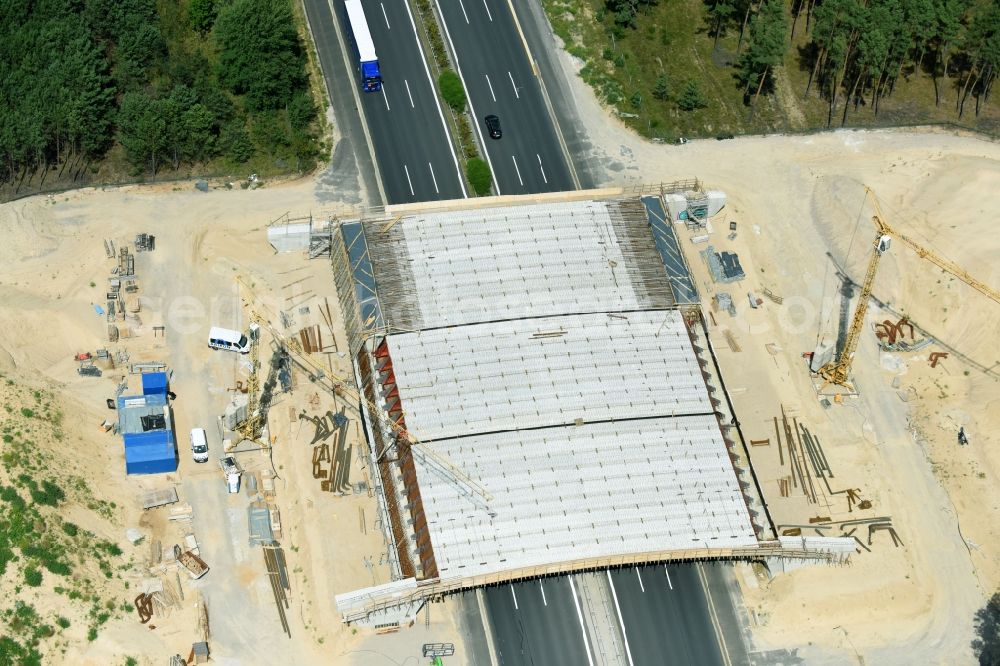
[305,0,576,203]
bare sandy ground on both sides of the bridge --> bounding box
[0,122,1000,664]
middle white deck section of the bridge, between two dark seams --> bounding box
[388,310,713,440]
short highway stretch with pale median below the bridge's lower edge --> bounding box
[485,564,747,666]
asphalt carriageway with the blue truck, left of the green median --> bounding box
[306,0,466,204]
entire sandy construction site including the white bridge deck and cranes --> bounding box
[0,126,1000,664]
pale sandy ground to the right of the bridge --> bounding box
[540,41,1000,664]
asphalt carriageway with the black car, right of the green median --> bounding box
[438,0,576,194]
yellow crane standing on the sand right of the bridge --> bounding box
[819,187,1000,388]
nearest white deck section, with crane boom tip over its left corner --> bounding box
[414,416,757,579]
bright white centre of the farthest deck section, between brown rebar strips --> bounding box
[386,202,650,328]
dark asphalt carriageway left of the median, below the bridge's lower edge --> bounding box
[485,576,595,666]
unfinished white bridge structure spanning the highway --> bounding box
[333,192,853,625]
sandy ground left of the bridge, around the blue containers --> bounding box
[0,176,476,666]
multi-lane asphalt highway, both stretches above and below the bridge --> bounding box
[305,0,746,666]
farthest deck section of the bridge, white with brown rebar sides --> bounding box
[366,201,673,330]
